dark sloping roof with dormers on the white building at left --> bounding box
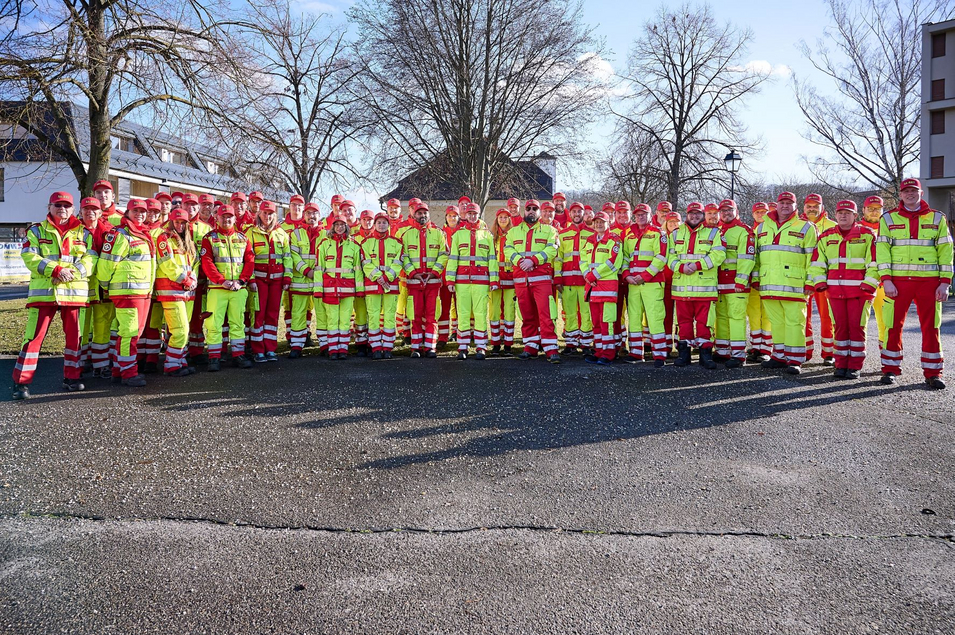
[0,104,291,200]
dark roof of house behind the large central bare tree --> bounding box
[380,153,554,202]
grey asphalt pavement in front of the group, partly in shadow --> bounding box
[0,307,955,634]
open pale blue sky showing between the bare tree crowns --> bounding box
[298,0,830,206]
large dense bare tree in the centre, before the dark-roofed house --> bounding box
[350,0,603,202]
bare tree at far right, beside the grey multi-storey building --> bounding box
[794,0,952,197]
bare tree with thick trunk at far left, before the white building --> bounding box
[0,0,236,194]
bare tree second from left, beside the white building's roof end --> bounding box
[200,0,368,199]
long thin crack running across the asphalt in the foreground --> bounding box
[7,512,955,549]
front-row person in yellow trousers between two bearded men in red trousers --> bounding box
[445,203,500,360]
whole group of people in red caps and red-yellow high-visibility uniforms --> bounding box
[13,179,953,399]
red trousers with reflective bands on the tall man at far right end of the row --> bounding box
[882,278,943,377]
